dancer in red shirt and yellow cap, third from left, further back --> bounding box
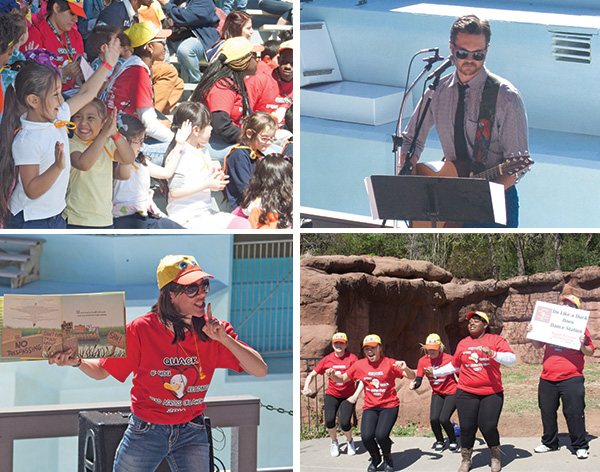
[409,333,458,452]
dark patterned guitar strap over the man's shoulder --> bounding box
[471,72,500,174]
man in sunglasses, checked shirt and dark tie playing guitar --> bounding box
[400,15,528,227]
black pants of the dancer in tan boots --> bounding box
[456,389,504,449]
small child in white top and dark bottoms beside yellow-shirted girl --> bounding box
[113,115,186,229]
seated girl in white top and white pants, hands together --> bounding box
[167,102,250,230]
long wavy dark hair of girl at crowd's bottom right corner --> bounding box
[241,154,294,229]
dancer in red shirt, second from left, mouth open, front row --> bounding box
[326,334,415,472]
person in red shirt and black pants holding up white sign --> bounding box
[529,295,594,459]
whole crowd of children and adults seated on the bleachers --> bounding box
[0,0,293,230]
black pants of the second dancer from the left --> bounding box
[360,406,399,457]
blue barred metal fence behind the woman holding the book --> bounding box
[231,239,293,354]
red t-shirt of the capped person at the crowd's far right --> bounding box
[246,70,294,123]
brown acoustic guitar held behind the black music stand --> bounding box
[411,153,534,228]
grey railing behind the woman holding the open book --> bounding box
[0,395,260,472]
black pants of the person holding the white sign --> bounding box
[538,377,588,449]
